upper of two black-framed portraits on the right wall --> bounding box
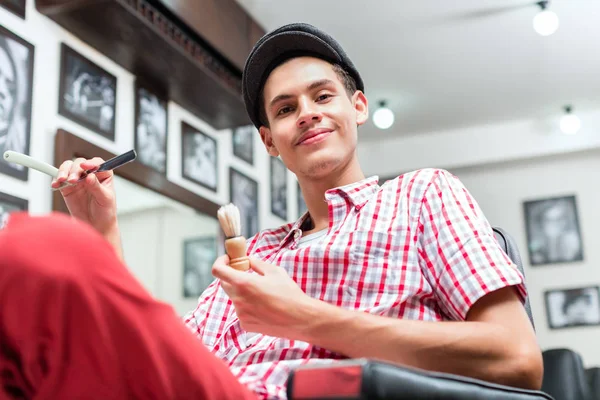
[524,196,583,265]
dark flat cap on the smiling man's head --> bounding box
[242,23,365,128]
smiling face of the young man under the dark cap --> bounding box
[260,57,368,179]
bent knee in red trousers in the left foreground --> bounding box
[0,214,256,400]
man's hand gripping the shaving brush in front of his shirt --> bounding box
[212,255,320,340]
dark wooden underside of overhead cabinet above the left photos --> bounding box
[36,0,250,129]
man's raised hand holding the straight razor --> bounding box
[52,157,119,241]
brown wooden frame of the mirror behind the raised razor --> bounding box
[52,129,220,218]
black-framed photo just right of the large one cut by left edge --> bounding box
[58,43,117,141]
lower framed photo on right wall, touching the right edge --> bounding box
[545,286,600,329]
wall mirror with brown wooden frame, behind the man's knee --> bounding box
[52,130,224,315]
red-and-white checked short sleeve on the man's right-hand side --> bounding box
[418,170,526,320]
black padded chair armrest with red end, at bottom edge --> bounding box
[287,359,553,400]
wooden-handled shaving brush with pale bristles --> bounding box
[217,203,250,271]
